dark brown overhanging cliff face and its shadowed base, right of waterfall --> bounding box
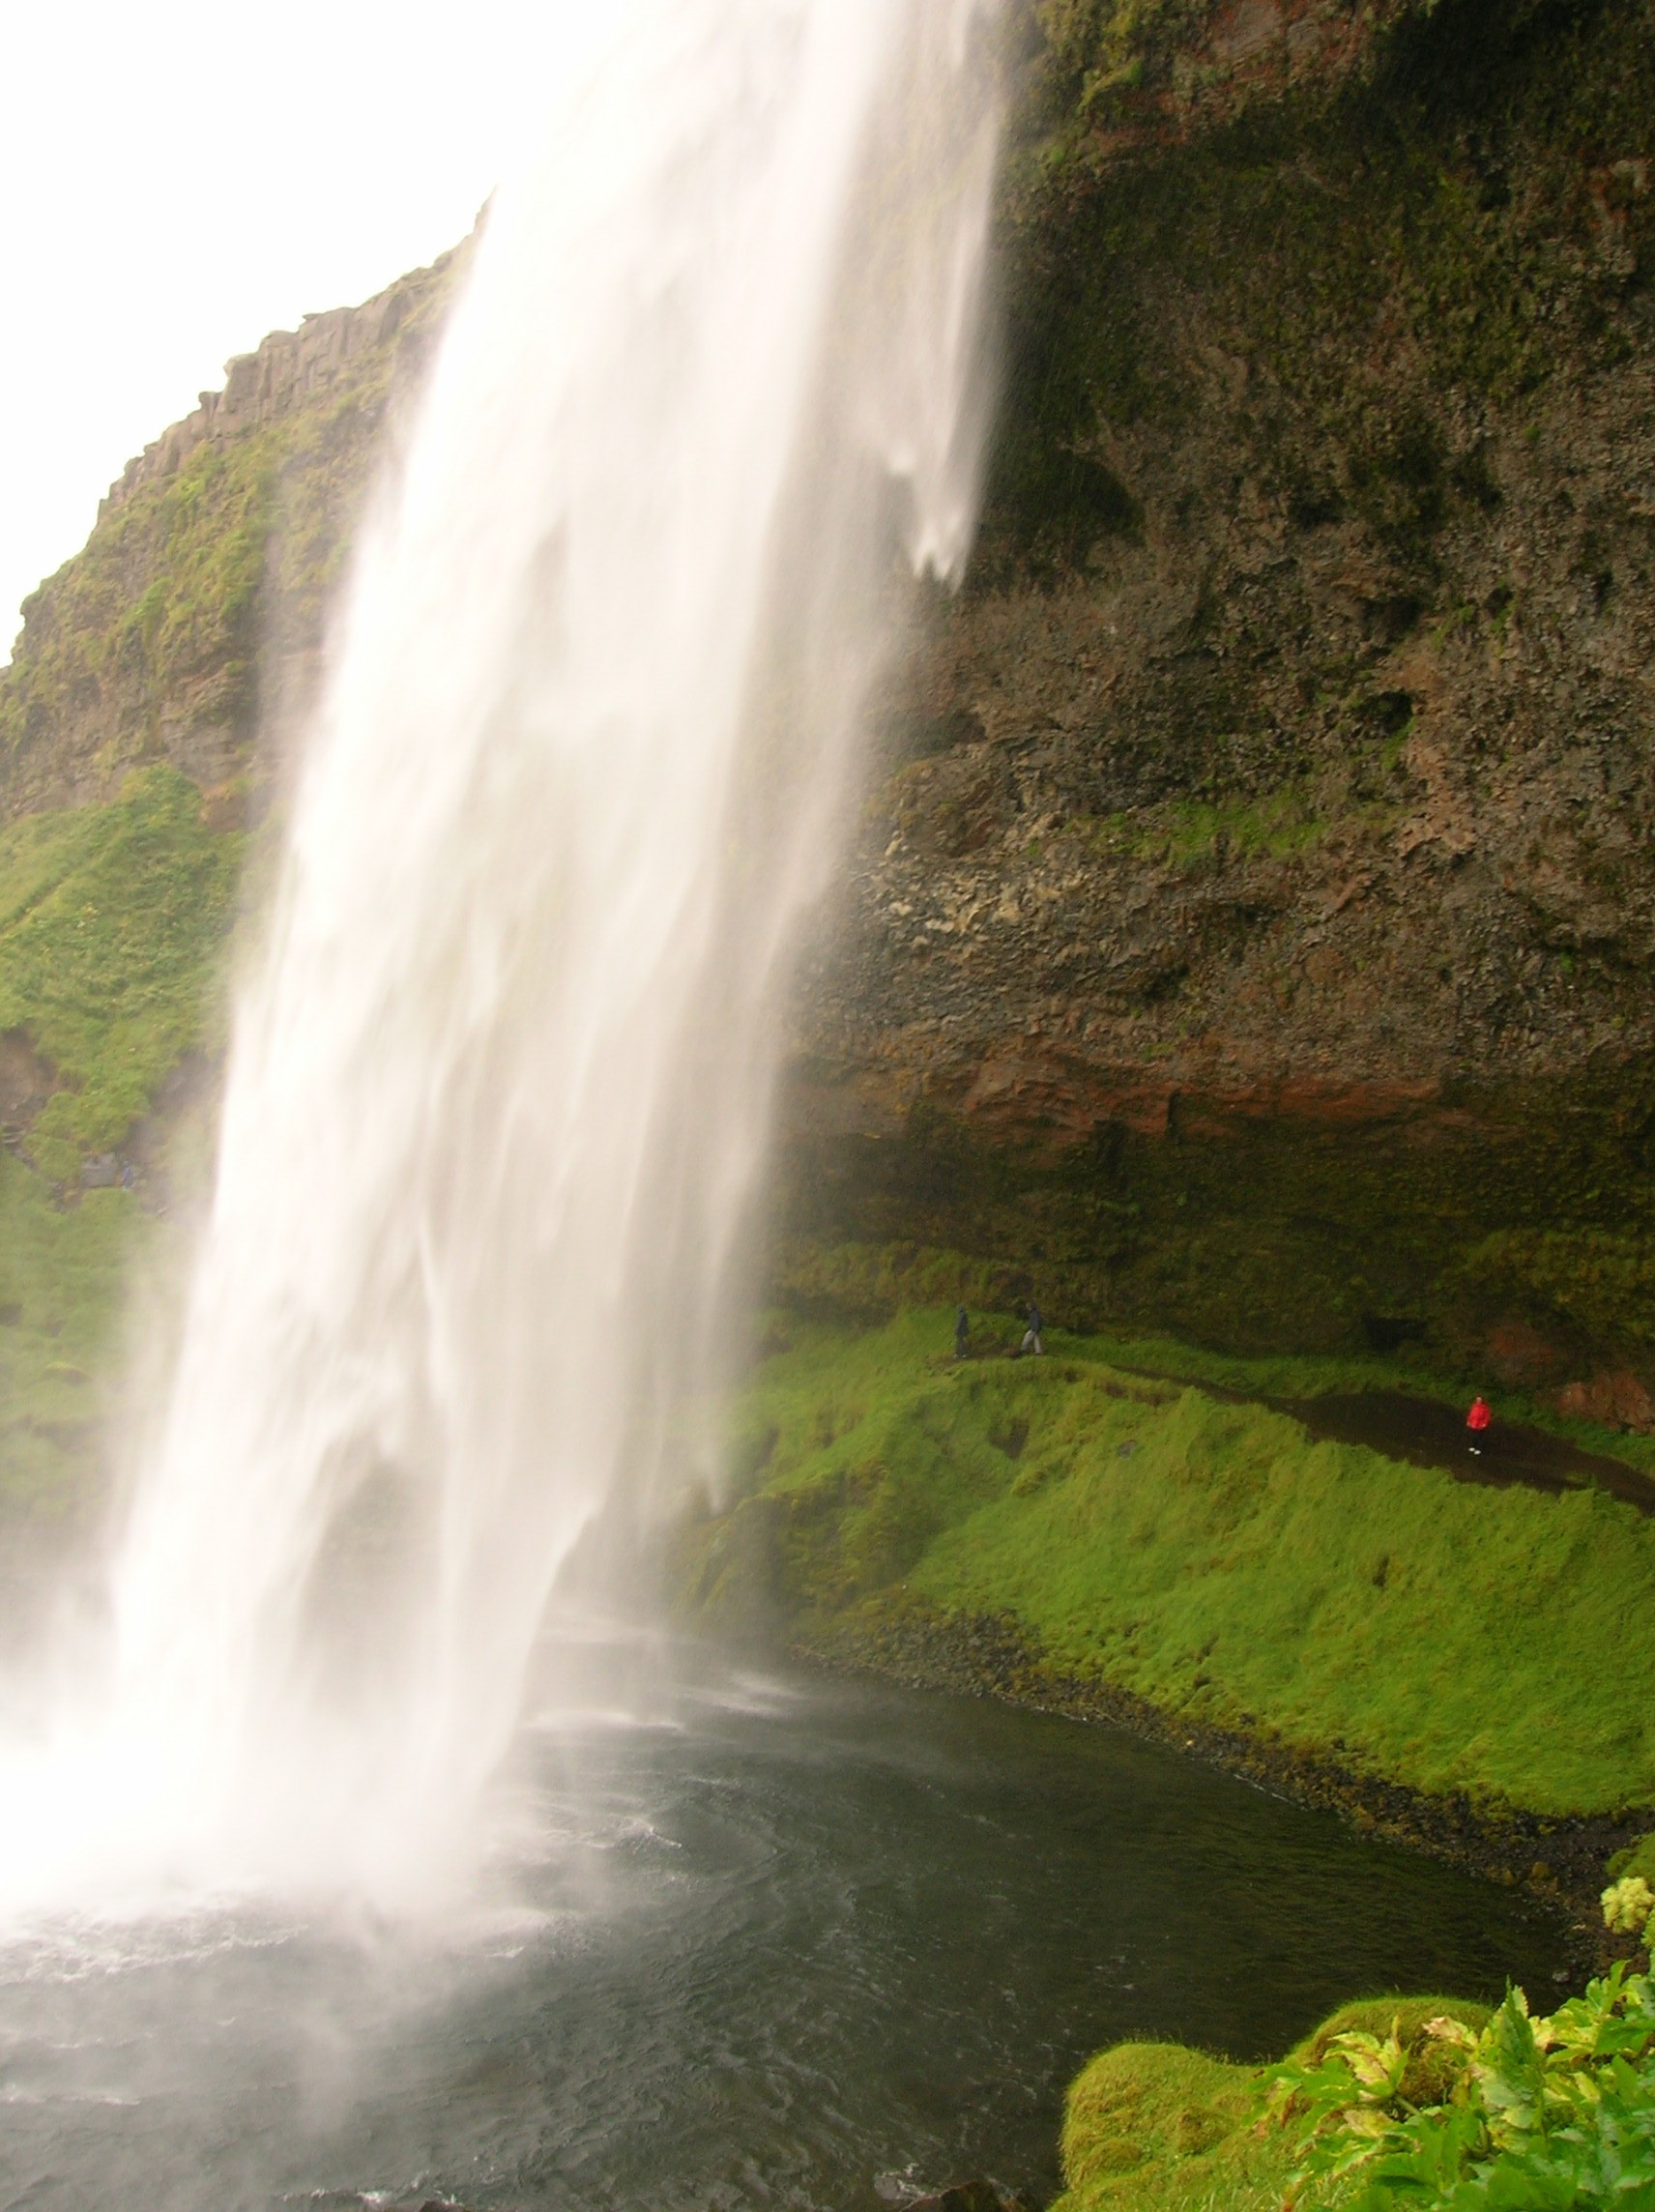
[790,0,1655,1381]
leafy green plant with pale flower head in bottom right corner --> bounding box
[1265,1876,1655,2212]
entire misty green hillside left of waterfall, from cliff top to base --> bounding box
[0,266,447,1520]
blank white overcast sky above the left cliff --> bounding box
[0,0,606,661]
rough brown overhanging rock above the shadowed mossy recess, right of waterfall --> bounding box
[805,0,1655,1139]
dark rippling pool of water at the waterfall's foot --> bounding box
[0,1644,1564,2212]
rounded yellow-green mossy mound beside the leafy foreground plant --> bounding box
[1053,1997,1489,2212]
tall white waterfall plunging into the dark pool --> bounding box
[0,0,998,1903]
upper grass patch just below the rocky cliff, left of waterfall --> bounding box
[0,768,244,1181]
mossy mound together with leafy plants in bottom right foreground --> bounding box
[1053,1878,1655,2212]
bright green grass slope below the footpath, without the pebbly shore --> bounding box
[699,1314,1655,1814]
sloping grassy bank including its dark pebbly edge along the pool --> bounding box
[668,1309,1655,1944]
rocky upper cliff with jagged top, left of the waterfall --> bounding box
[0,242,455,819]
